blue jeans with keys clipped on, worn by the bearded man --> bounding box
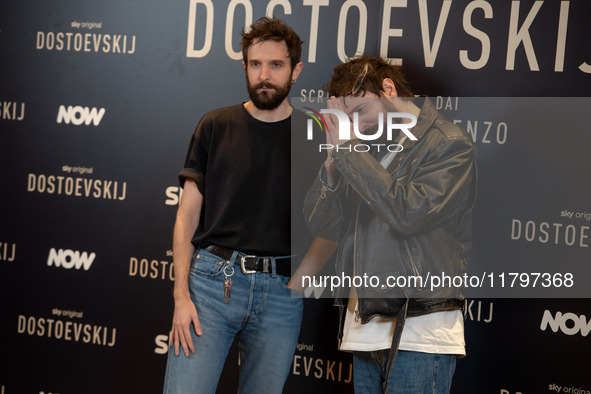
[164,249,303,394]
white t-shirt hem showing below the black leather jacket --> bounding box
[340,289,466,356]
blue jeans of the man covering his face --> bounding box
[353,350,456,394]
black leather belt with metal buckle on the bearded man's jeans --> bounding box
[205,245,291,276]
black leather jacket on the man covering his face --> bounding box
[304,98,476,323]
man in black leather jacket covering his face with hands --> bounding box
[304,56,476,394]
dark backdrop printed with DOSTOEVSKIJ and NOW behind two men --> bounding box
[0,0,591,394]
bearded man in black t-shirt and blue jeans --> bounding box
[164,18,336,394]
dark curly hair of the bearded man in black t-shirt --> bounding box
[240,16,304,70]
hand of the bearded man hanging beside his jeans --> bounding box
[170,295,203,357]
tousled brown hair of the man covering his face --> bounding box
[324,55,413,97]
